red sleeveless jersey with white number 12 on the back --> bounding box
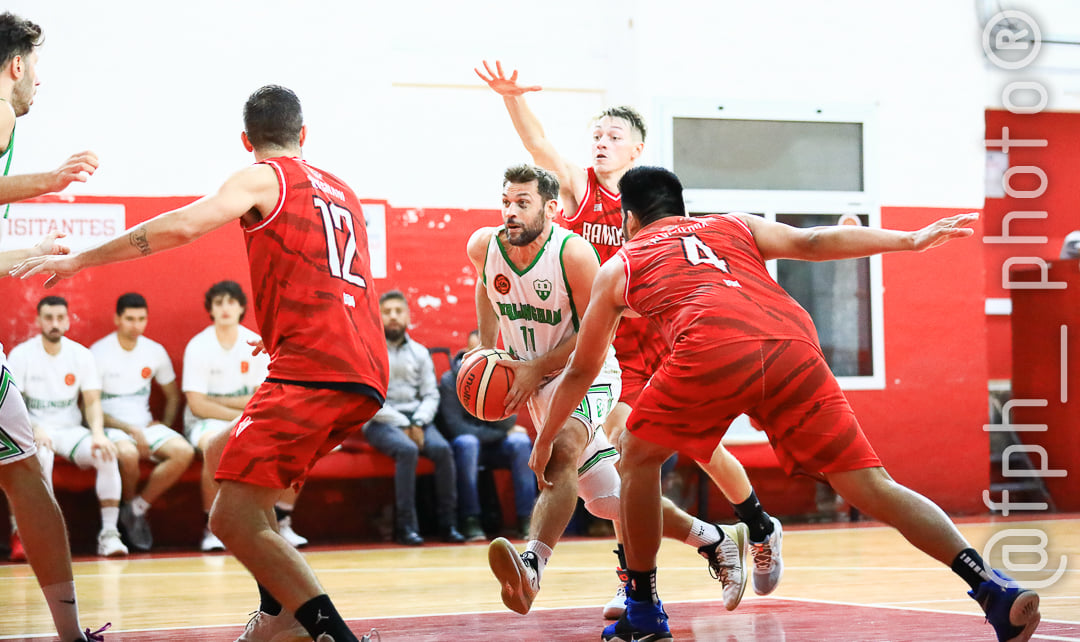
[244,157,389,397]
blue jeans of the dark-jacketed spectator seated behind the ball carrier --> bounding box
[454,432,537,518]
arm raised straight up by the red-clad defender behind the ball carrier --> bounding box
[473,61,588,212]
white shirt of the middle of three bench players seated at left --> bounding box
[90,332,176,428]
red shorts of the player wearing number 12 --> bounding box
[214,382,381,490]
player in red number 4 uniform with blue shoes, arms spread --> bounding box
[530,168,1040,642]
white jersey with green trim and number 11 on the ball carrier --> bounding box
[483,226,618,370]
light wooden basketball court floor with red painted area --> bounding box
[0,516,1080,642]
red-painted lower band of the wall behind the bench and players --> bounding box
[0,198,989,512]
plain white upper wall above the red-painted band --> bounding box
[8,0,1054,208]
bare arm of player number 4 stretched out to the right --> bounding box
[735,212,978,260]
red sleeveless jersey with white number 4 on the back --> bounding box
[621,215,818,348]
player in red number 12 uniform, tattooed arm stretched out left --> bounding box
[15,85,388,642]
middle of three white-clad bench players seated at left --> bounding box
[90,292,195,550]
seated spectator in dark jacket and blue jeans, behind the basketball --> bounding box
[435,330,537,541]
